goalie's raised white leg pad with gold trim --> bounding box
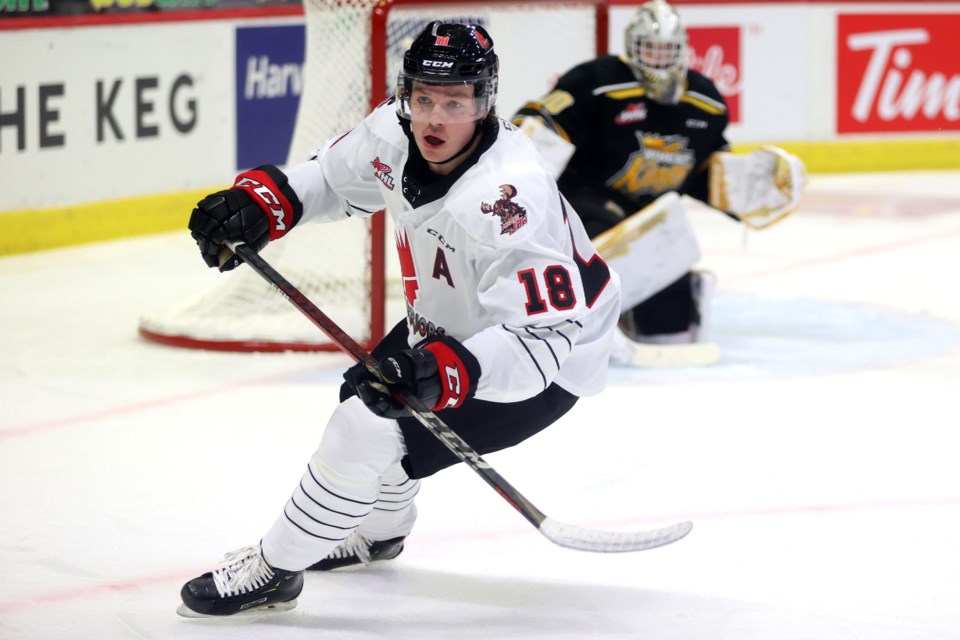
[593,191,700,311]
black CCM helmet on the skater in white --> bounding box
[397,20,499,119]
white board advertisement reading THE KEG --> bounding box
[0,23,234,211]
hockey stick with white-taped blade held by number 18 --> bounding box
[227,242,693,553]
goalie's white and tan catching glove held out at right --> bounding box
[710,146,807,229]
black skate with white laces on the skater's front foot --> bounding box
[177,545,303,618]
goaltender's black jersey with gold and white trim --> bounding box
[514,55,729,236]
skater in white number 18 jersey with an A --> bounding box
[179,22,620,616]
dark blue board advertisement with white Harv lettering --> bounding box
[236,24,304,170]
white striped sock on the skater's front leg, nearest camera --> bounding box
[261,398,403,571]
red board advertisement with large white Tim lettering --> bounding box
[837,13,960,133]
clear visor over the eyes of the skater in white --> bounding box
[397,73,489,124]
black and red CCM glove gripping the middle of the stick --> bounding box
[343,337,480,418]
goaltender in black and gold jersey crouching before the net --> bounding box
[514,0,803,362]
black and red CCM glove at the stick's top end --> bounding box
[187,165,303,271]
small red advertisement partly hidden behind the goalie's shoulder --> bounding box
[689,27,743,122]
